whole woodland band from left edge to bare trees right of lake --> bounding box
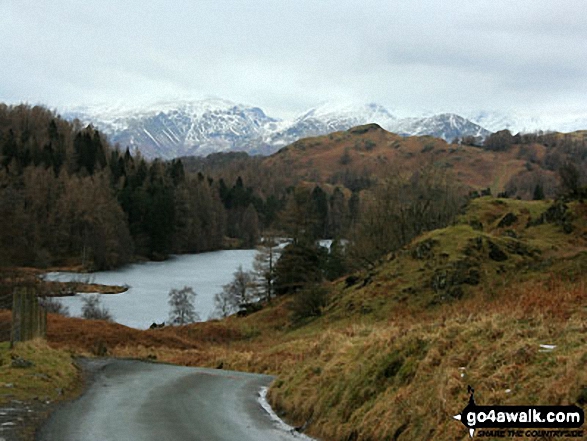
[0,105,506,308]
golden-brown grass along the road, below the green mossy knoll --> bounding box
[39,276,587,440]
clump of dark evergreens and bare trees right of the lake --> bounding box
[215,166,467,321]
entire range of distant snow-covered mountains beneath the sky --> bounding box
[62,99,500,159]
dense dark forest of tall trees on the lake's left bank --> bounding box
[0,105,255,269]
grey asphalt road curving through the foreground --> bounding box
[37,360,308,441]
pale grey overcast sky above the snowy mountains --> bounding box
[0,0,587,117]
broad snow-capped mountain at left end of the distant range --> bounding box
[64,100,277,159]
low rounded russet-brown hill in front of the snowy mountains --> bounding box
[263,124,545,193]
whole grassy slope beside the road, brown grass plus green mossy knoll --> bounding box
[34,199,587,440]
